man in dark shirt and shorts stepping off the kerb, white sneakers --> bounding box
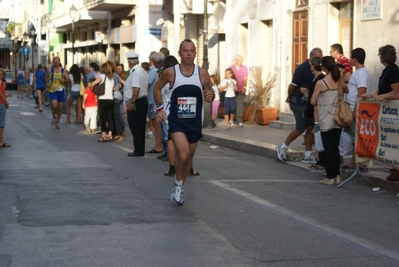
[276,48,323,164]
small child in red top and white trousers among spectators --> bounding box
[82,78,97,132]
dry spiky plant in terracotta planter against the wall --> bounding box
[248,67,279,125]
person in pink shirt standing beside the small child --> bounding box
[230,55,248,127]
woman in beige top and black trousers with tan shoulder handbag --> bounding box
[311,56,343,185]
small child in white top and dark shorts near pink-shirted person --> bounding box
[219,68,237,128]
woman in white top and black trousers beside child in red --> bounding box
[89,63,115,142]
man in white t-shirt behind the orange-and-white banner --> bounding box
[340,48,370,170]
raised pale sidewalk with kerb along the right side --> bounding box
[202,119,399,192]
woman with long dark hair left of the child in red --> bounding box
[62,64,83,124]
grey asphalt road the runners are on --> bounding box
[0,97,399,267]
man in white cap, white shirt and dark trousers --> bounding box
[123,50,148,157]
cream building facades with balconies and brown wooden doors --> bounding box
[3,0,399,118]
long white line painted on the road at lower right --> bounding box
[209,181,399,261]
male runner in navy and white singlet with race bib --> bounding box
[154,39,215,205]
